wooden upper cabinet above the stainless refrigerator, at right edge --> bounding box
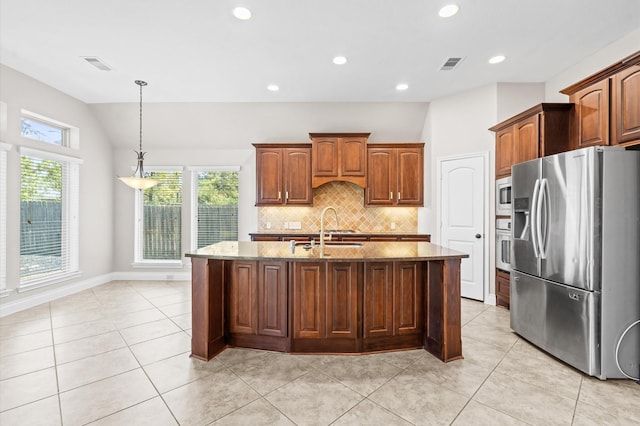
[561,51,640,149]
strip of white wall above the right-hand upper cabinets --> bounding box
[545,28,640,102]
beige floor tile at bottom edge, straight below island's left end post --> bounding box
[162,369,260,425]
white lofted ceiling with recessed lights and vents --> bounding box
[0,0,640,103]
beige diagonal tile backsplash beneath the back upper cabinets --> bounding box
[258,182,418,234]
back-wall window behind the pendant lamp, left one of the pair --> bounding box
[135,168,182,263]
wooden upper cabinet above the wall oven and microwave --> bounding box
[489,103,573,178]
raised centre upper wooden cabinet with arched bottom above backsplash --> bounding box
[309,133,369,188]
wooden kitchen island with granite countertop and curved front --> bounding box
[187,241,468,362]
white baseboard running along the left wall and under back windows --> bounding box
[0,271,191,318]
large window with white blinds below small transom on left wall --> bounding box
[20,147,80,288]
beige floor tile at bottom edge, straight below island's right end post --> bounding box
[369,373,468,425]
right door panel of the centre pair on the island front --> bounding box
[325,262,360,339]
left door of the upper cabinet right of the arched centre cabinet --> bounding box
[365,148,396,206]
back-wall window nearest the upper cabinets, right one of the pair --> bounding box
[191,167,240,249]
